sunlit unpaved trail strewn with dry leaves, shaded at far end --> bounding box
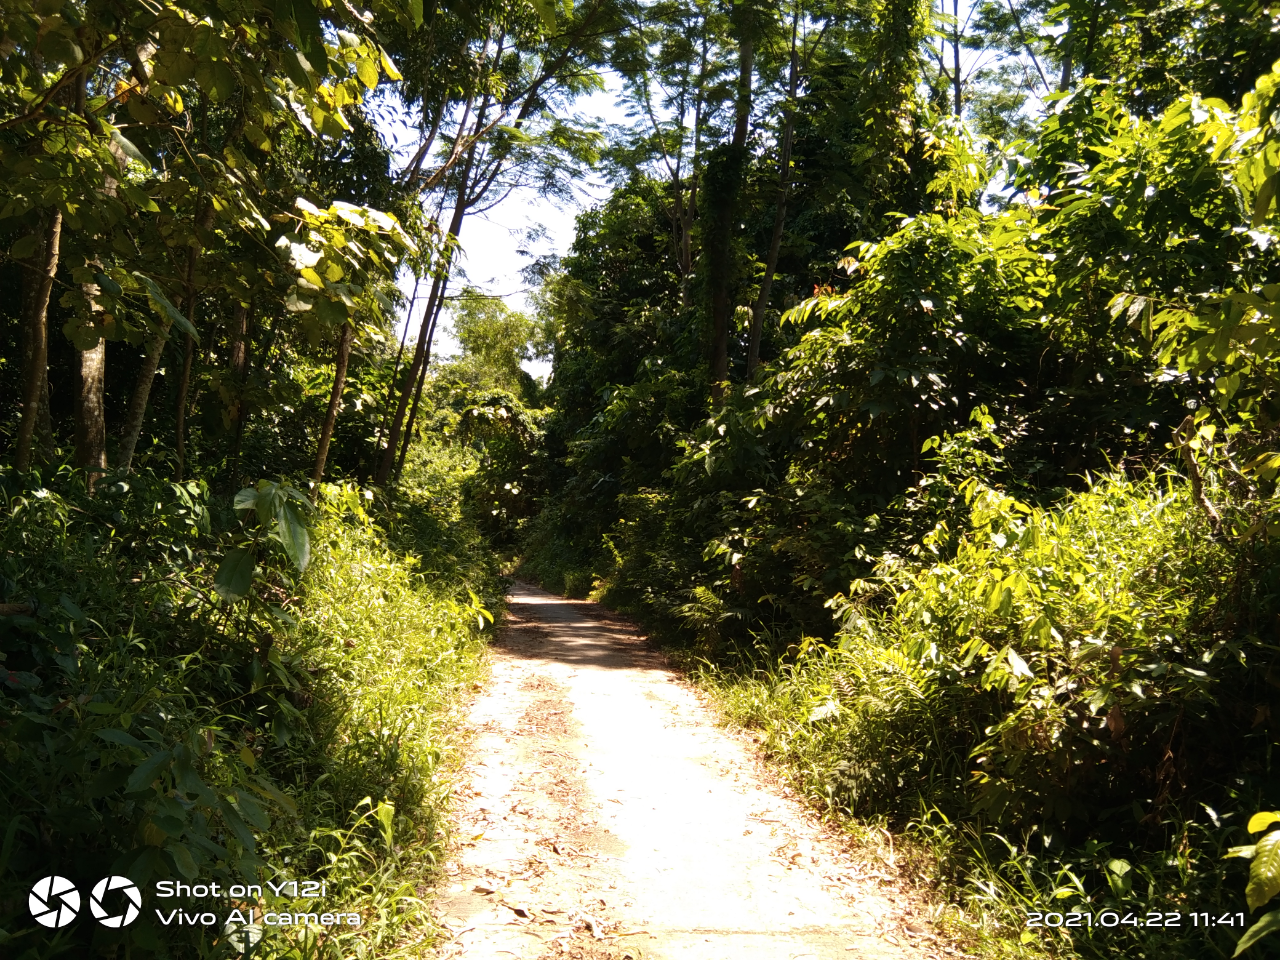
[435,584,931,960]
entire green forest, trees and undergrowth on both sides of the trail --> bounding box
[0,0,1280,960]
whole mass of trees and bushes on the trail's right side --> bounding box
[512,1,1280,957]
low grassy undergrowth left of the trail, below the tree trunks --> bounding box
[0,452,500,960]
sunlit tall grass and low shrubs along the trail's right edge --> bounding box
[700,475,1280,960]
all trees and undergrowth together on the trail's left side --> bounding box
[0,0,560,959]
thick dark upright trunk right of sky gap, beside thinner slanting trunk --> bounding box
[707,24,755,401]
